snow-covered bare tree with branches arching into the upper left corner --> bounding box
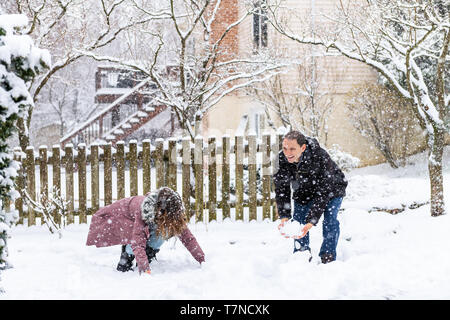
[2,0,155,150]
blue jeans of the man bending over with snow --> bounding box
[293,197,342,260]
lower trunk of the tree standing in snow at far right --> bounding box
[428,128,445,217]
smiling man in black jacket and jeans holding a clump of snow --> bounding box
[273,131,347,263]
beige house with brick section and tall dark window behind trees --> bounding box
[199,0,384,165]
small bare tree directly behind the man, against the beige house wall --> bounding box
[247,52,343,145]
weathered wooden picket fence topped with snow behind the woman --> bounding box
[12,134,281,226]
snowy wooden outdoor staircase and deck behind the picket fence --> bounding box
[60,65,176,146]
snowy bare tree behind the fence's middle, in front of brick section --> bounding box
[82,0,285,138]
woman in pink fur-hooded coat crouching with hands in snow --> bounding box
[86,187,205,273]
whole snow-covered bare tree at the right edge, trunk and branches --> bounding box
[269,0,450,216]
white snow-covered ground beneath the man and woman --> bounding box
[0,148,450,300]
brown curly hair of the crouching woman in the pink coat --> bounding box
[155,187,186,239]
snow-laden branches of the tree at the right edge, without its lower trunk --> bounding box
[269,0,450,133]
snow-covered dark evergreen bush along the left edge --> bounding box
[0,9,50,269]
